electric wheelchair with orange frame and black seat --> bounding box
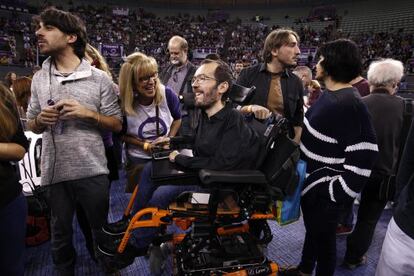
[101,84,299,276]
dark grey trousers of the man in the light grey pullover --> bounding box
[48,175,109,275]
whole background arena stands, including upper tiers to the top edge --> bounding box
[0,0,414,92]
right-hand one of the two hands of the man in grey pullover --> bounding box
[54,99,95,120]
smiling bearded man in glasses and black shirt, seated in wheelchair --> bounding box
[99,60,270,268]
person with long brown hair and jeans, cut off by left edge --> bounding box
[0,84,29,275]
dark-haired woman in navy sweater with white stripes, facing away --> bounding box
[288,39,378,276]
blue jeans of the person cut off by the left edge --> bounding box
[0,195,27,276]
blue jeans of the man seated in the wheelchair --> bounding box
[131,162,201,248]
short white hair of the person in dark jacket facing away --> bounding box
[367,58,404,87]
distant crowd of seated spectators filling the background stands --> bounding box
[0,6,414,75]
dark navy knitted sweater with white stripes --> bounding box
[300,88,378,203]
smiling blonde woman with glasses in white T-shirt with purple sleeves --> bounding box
[119,52,181,183]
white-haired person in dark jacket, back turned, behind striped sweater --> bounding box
[344,59,414,269]
